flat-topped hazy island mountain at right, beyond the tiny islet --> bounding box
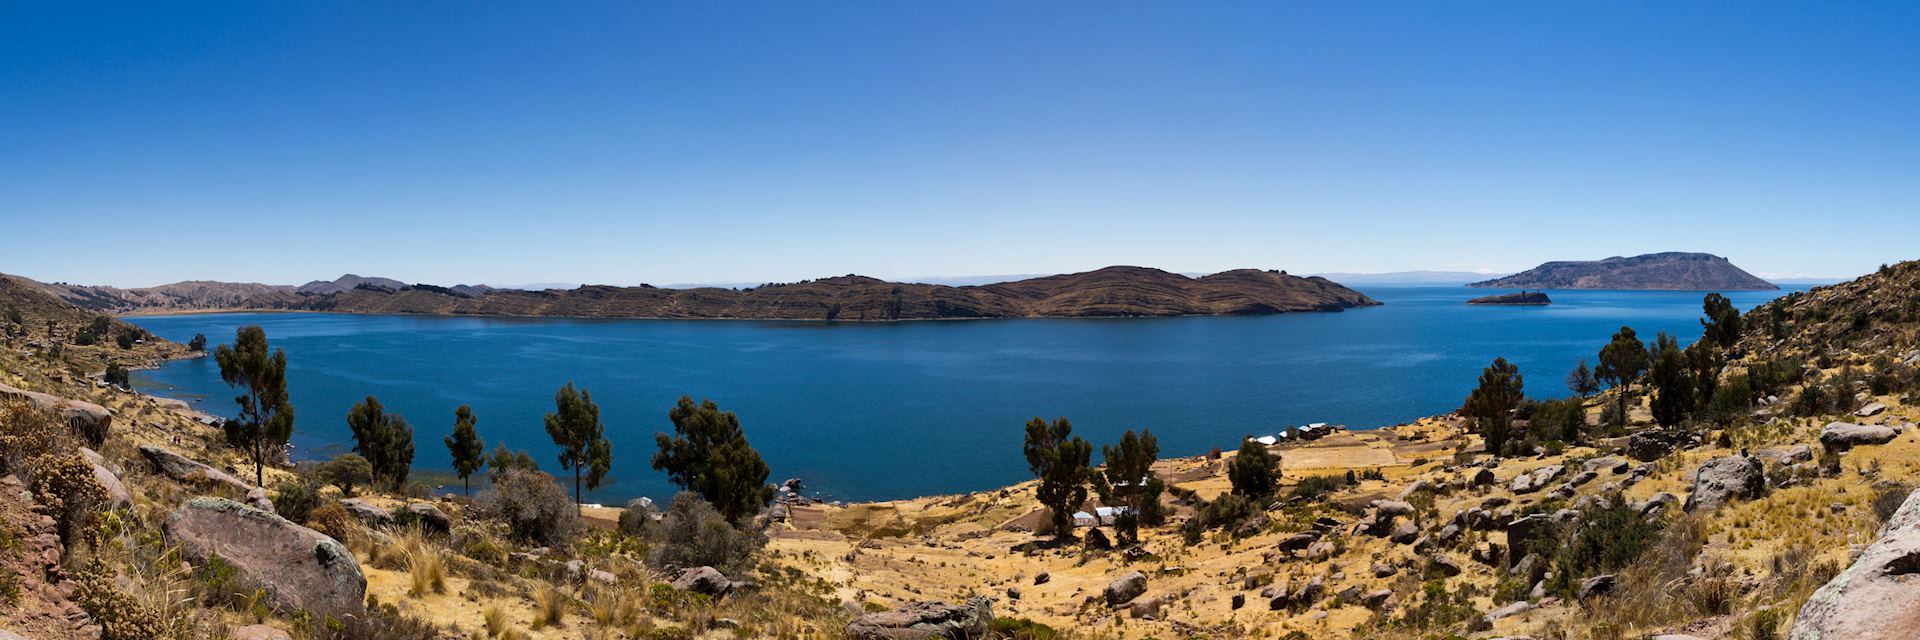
[1467,252,1780,290]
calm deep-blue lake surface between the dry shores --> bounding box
[129,286,1805,504]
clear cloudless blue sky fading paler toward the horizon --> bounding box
[0,0,1920,286]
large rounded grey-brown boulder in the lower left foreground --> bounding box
[165,498,367,617]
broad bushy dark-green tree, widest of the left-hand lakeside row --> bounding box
[653,396,774,523]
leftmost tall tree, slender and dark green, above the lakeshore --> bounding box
[213,327,294,484]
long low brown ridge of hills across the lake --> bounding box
[21,267,1379,321]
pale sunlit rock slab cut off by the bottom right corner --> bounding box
[1788,492,1920,640]
